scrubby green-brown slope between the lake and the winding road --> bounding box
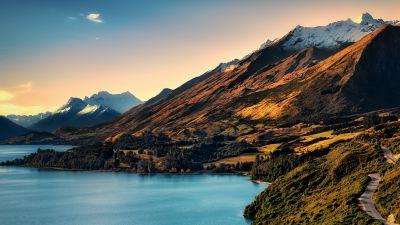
[245,140,385,224]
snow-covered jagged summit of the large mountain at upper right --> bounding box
[261,13,399,51]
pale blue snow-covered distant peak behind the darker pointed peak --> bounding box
[83,91,143,113]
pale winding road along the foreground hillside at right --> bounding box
[358,146,397,225]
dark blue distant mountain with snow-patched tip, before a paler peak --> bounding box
[30,98,120,132]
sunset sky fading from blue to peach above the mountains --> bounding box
[0,0,400,115]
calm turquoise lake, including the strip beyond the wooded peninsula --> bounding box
[0,146,266,225]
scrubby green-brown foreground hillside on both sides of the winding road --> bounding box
[245,119,400,224]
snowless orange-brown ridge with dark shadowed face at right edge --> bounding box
[236,25,400,119]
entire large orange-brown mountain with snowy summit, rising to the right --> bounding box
[57,13,400,143]
